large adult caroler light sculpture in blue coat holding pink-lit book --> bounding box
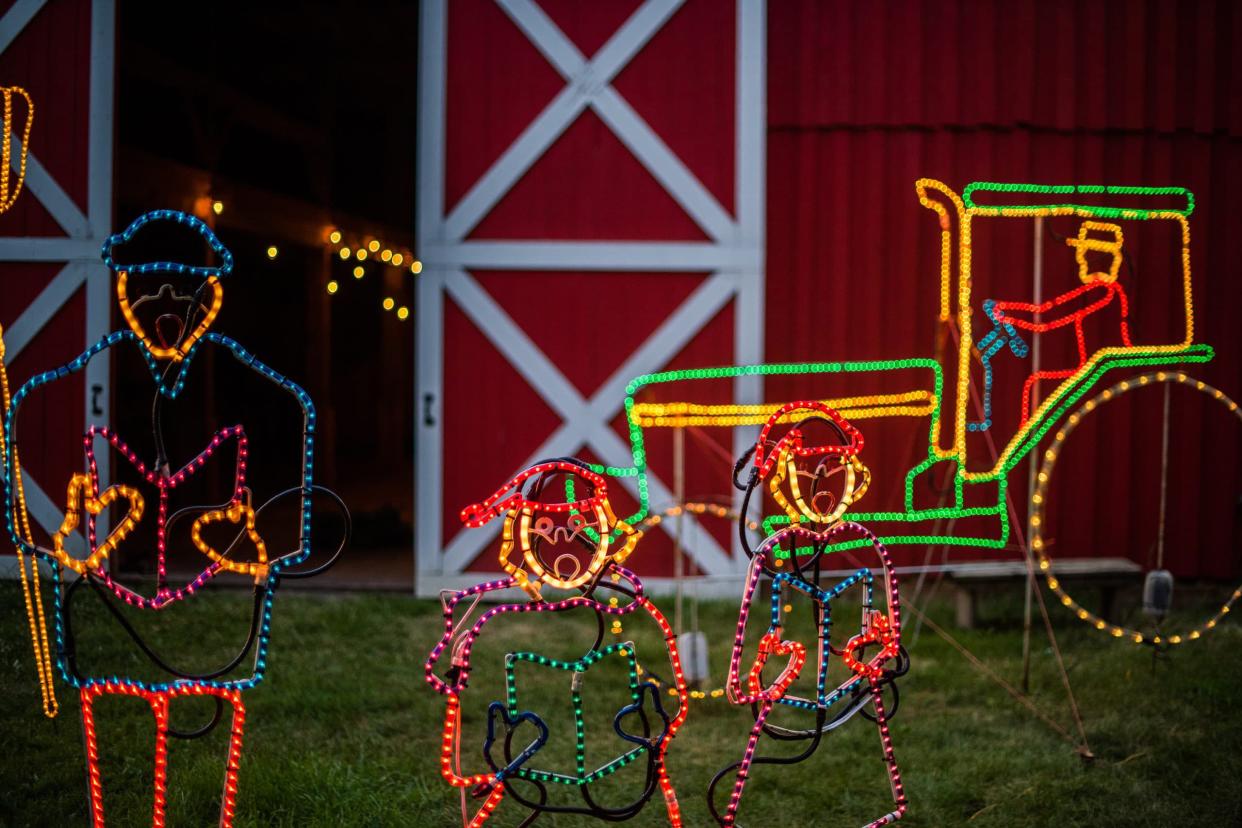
[2,210,350,826]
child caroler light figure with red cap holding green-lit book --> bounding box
[425,458,688,828]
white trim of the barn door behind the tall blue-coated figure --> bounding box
[0,0,116,576]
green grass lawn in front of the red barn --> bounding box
[0,581,1242,827]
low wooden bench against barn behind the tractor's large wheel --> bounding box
[944,557,1143,629]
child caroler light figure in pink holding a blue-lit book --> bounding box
[707,401,909,826]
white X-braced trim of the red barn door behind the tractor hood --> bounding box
[415,0,766,596]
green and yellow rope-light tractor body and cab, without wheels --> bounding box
[611,179,1215,551]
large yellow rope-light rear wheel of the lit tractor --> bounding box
[1031,371,1242,647]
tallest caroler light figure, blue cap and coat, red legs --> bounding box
[4,210,349,826]
